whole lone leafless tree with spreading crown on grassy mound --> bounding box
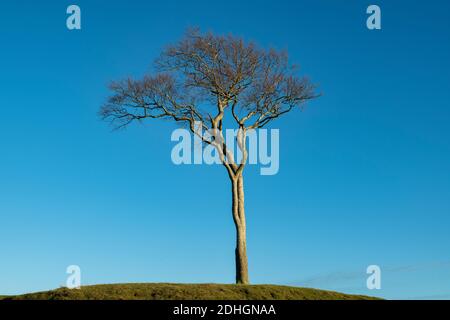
[100,30,316,284]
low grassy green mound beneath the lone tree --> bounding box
[3,283,382,300]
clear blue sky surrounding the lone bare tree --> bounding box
[0,0,450,299]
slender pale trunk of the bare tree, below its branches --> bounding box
[232,175,249,284]
